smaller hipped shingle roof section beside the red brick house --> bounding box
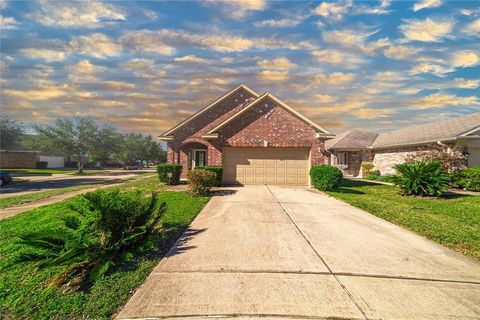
[325,129,378,149]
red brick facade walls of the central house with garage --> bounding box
[167,90,324,178]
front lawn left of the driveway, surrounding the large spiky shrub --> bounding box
[0,186,209,319]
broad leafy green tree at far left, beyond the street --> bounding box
[30,117,117,173]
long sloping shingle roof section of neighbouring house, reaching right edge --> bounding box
[371,112,480,148]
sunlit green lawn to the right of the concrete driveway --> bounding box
[327,180,480,259]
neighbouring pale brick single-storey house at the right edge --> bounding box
[325,112,480,176]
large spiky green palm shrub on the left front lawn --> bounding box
[20,189,167,286]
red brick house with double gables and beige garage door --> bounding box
[159,84,334,185]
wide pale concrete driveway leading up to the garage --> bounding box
[118,186,480,319]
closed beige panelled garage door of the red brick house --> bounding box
[223,148,310,185]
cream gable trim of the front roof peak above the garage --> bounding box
[204,92,334,138]
